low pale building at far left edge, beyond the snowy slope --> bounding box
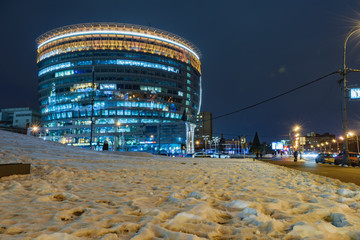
[0,107,41,129]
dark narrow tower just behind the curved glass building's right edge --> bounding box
[195,112,213,149]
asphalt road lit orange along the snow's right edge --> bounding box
[260,157,360,186]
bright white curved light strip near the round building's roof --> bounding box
[38,30,200,60]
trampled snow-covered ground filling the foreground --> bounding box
[0,131,360,240]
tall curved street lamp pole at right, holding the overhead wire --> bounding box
[341,25,360,165]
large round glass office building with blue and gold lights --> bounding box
[36,23,201,153]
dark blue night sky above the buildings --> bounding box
[0,0,360,142]
